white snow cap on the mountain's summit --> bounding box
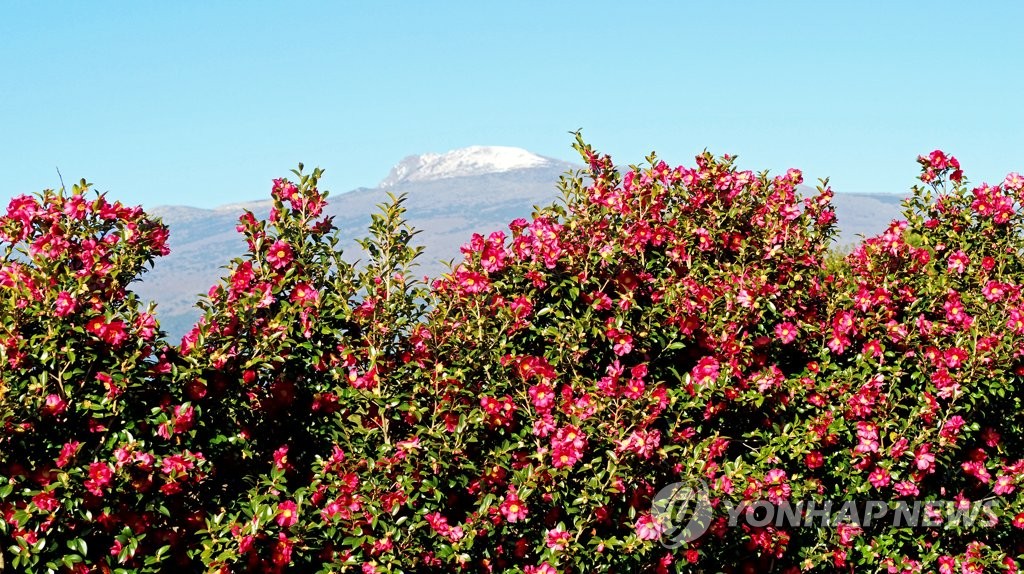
[380,145,556,187]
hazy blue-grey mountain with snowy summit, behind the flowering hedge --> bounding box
[135,146,900,340]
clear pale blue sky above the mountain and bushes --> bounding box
[0,0,1024,207]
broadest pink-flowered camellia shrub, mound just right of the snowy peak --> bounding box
[413,136,835,571]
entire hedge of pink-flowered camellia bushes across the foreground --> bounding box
[0,138,1024,574]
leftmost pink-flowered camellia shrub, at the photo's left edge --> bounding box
[0,181,201,571]
